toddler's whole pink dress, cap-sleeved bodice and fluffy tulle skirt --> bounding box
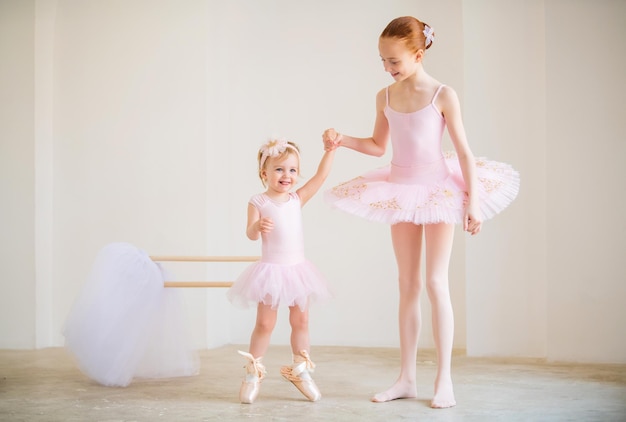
[227,192,331,310]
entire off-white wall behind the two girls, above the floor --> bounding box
[0,0,626,362]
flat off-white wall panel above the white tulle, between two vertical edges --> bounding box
[52,1,209,345]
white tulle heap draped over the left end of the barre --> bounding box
[64,243,199,387]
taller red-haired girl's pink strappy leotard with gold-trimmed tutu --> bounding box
[324,85,520,224]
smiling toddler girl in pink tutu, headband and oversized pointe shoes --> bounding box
[227,140,334,403]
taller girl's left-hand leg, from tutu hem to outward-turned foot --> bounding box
[372,223,423,402]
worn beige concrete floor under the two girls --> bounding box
[0,346,626,422]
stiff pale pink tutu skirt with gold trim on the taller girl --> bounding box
[324,152,520,224]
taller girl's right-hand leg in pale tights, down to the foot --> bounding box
[425,224,456,408]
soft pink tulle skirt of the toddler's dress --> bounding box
[227,259,331,311]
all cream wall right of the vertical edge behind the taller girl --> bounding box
[463,0,626,362]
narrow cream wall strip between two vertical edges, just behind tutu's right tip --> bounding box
[463,0,552,357]
